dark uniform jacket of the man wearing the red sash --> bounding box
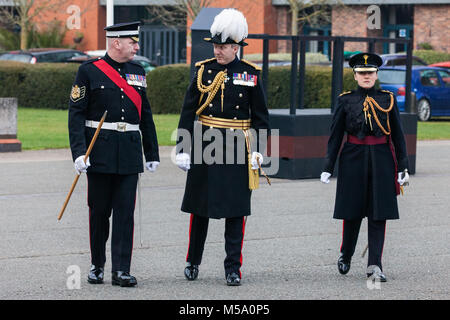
[69,54,159,174]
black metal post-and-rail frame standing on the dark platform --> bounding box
[240,34,412,114]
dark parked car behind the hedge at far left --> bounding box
[0,48,89,64]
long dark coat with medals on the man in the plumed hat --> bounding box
[177,58,269,219]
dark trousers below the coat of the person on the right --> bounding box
[341,217,386,270]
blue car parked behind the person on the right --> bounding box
[378,66,450,121]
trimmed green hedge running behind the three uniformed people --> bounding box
[0,61,370,114]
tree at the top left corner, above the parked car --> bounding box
[0,0,67,50]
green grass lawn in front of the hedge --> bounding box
[17,108,450,150]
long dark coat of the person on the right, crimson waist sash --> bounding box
[323,86,408,220]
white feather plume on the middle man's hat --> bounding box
[209,9,248,42]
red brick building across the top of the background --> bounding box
[0,0,450,63]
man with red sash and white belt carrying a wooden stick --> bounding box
[69,22,159,286]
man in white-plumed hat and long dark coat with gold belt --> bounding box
[176,9,269,286]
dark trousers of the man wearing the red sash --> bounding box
[87,173,138,272]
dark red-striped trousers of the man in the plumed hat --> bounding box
[186,214,245,277]
